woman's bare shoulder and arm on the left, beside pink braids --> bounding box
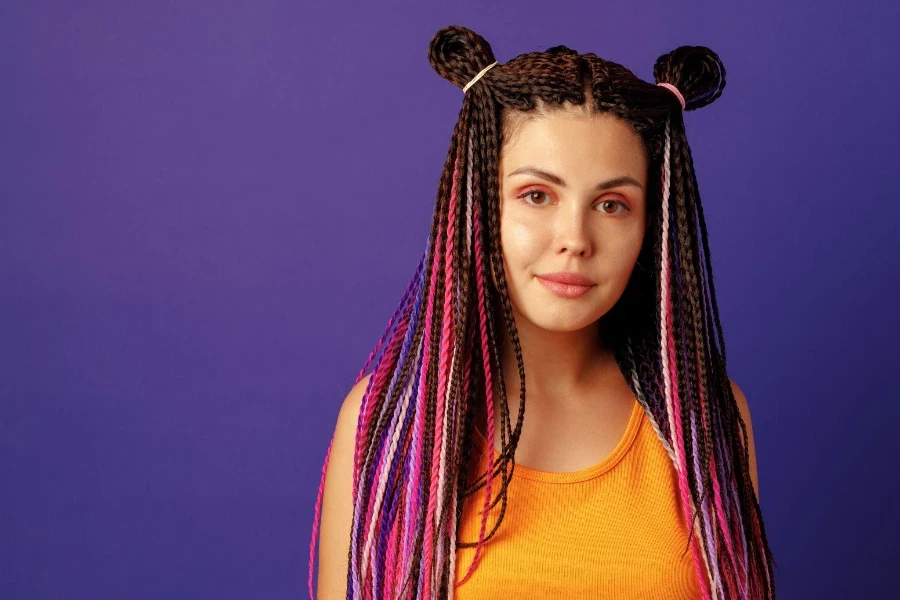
[316,373,372,600]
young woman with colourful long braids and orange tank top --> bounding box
[309,27,775,600]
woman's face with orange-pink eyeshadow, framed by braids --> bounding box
[500,110,647,331]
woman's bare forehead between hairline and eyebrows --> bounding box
[500,111,647,187]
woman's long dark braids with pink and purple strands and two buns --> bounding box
[309,26,775,599]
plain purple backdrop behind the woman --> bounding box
[0,0,900,599]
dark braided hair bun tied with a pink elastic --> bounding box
[653,46,725,110]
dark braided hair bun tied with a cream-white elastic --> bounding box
[428,25,496,88]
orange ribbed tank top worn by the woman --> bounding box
[454,400,701,600]
